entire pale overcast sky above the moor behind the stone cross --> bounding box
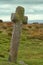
[0,0,43,21]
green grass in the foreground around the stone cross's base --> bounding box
[0,30,43,65]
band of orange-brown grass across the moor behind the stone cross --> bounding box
[0,22,43,38]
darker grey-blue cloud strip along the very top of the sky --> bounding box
[0,0,43,4]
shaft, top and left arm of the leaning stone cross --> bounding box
[9,7,24,62]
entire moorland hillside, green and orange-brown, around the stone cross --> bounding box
[0,23,43,65]
